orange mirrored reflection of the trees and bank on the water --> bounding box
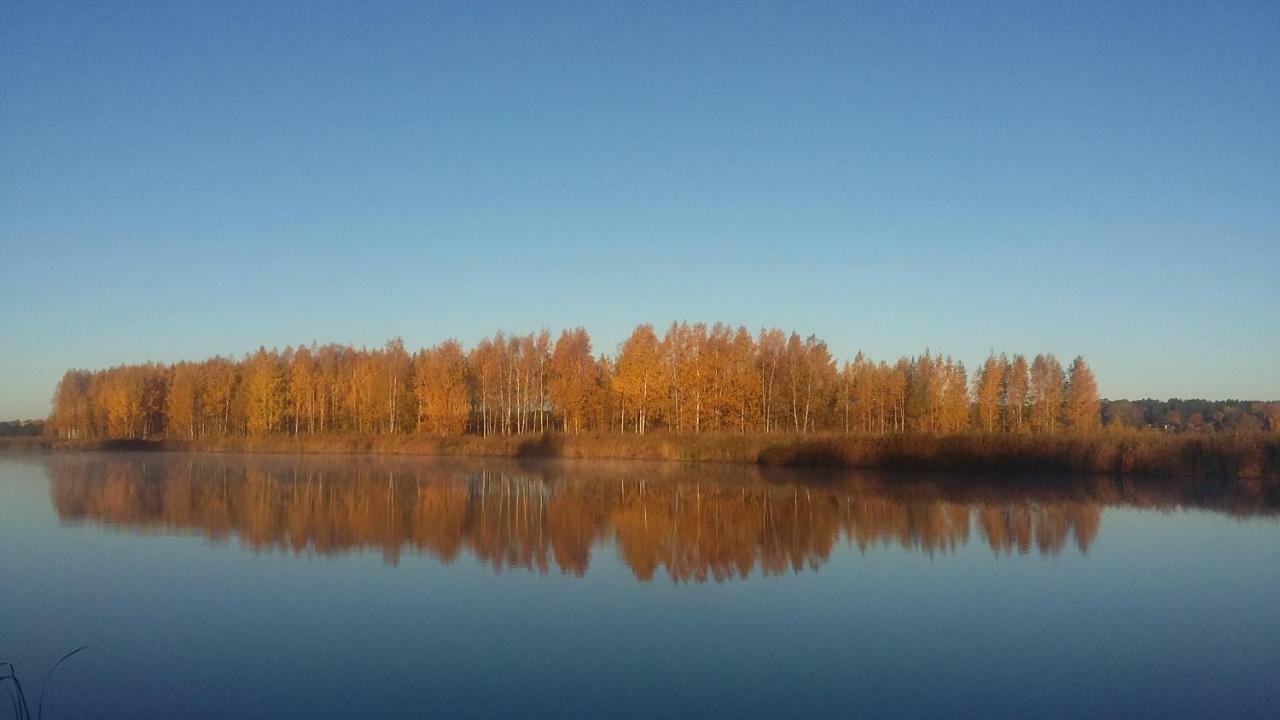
[50,456,1276,582]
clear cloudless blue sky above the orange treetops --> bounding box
[0,0,1280,419]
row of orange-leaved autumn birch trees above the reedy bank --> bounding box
[49,323,1101,438]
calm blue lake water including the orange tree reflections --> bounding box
[0,454,1280,717]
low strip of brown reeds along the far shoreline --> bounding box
[0,432,1280,482]
